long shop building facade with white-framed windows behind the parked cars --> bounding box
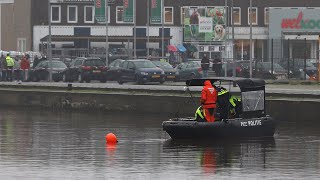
[32,0,320,61]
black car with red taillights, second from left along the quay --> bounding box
[63,57,108,83]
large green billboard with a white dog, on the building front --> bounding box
[183,6,226,42]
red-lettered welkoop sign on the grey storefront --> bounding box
[281,11,320,29]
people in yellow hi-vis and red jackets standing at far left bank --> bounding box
[0,53,30,82]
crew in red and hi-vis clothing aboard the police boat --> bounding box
[195,80,241,122]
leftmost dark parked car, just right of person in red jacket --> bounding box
[28,60,67,82]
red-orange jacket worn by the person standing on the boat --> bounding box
[200,80,218,109]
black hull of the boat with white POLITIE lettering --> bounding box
[162,116,275,139]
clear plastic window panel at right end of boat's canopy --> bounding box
[241,90,264,112]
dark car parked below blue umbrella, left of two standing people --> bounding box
[175,61,202,80]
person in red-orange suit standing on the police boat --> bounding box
[200,80,218,122]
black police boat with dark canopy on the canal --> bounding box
[162,77,275,139]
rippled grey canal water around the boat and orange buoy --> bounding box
[0,108,320,180]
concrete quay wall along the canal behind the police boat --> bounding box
[0,84,320,121]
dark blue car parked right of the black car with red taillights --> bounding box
[118,59,165,84]
